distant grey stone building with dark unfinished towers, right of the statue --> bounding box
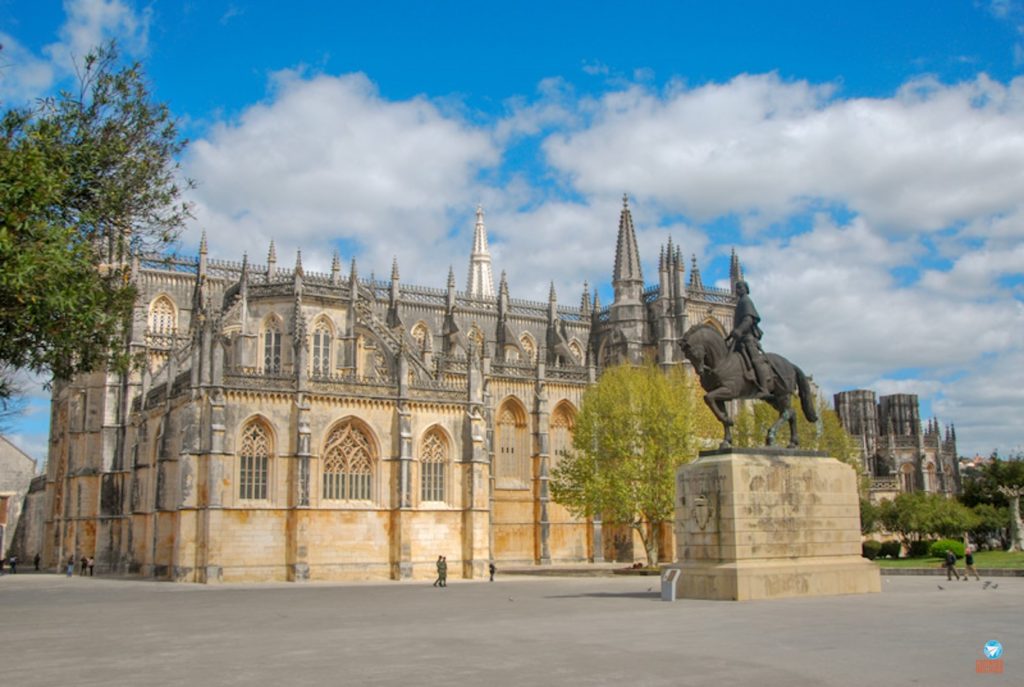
[835,389,961,503]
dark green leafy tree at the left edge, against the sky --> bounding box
[0,43,189,398]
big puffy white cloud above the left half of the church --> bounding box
[184,72,499,280]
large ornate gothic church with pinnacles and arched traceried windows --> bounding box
[40,197,740,583]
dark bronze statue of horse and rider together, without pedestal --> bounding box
[680,282,818,448]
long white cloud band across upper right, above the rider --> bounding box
[545,74,1024,231]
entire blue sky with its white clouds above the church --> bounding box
[0,0,1024,464]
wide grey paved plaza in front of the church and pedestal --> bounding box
[0,572,1024,687]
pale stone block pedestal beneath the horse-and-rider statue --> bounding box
[673,448,881,601]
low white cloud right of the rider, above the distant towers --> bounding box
[740,219,1024,453]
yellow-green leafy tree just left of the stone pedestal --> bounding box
[551,363,721,565]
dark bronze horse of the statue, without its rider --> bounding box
[680,325,818,448]
